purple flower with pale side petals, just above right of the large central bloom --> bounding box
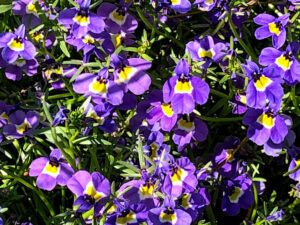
[186,36,227,69]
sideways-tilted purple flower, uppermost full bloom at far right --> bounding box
[253,13,290,49]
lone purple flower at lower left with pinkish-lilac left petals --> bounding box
[29,149,74,191]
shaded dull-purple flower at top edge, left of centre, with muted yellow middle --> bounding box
[97,2,138,34]
